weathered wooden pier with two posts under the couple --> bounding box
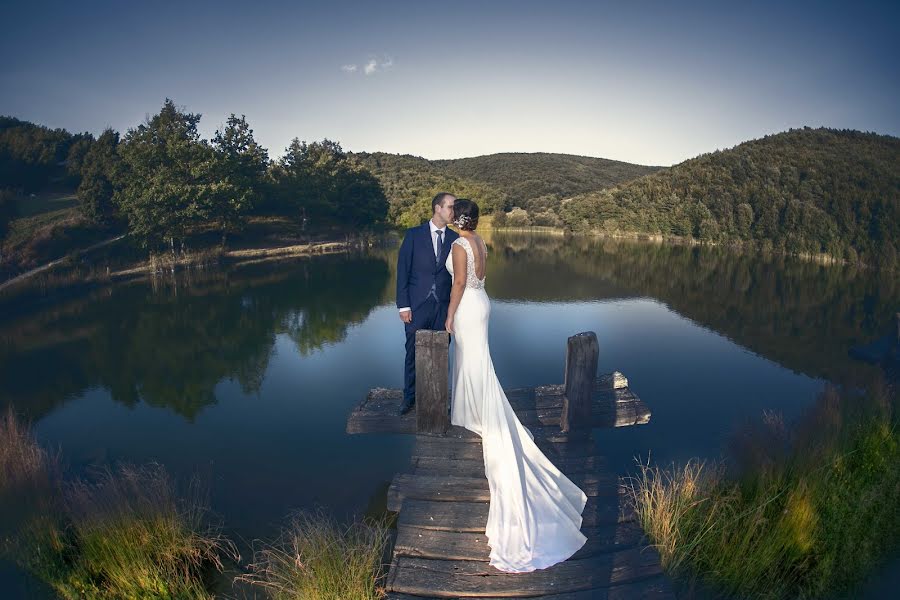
[347,331,675,600]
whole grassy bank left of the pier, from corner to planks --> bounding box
[0,410,389,600]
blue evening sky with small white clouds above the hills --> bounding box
[0,0,900,166]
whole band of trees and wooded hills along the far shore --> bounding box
[0,110,900,268]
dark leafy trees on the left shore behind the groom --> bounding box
[0,99,388,254]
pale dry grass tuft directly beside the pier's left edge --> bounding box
[238,509,389,600]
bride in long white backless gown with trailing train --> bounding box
[446,198,587,573]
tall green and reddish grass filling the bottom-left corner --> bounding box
[0,409,238,600]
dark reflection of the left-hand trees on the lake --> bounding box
[0,256,388,420]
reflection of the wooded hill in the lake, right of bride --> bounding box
[478,233,900,383]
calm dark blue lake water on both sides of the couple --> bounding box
[0,234,900,596]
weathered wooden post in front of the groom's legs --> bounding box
[416,329,450,435]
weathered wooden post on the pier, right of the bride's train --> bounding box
[559,331,600,433]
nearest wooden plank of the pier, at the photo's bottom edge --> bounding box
[386,548,662,598]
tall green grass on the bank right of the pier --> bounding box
[628,387,900,598]
